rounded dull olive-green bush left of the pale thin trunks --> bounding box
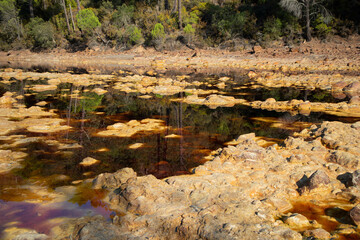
[25,17,56,49]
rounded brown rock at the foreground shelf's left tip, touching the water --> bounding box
[93,168,136,189]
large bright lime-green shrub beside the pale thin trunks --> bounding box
[76,8,101,35]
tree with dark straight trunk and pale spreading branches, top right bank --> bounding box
[279,0,331,41]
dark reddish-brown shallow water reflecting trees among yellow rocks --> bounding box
[0,66,358,237]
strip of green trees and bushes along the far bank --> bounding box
[0,0,360,52]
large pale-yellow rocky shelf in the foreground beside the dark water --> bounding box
[21,122,360,239]
